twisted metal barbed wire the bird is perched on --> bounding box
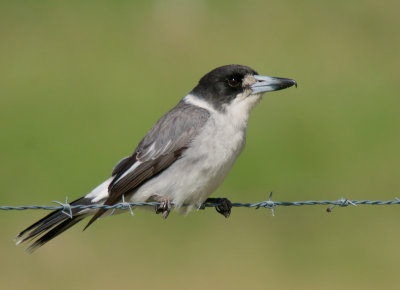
[0,193,400,218]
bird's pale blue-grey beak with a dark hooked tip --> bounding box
[250,75,297,95]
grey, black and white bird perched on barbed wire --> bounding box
[16,64,297,252]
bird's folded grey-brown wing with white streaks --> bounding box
[86,102,210,228]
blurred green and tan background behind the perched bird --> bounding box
[0,0,400,289]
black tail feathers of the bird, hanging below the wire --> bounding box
[16,197,91,252]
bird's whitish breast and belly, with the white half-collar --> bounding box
[128,95,260,211]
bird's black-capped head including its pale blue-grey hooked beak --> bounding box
[191,65,297,110]
